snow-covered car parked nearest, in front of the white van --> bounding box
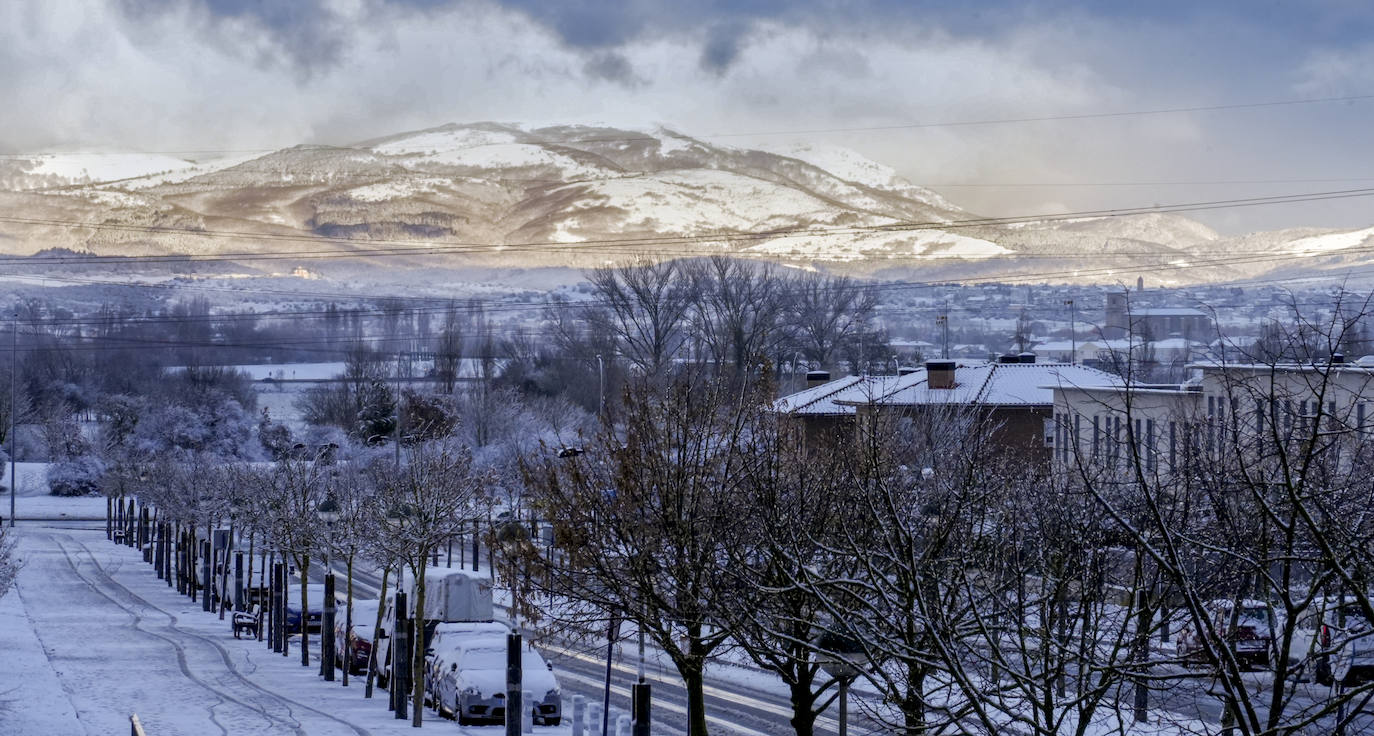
[434,637,563,726]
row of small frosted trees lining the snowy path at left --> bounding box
[136,442,492,725]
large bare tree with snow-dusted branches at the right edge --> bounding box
[1074,295,1374,735]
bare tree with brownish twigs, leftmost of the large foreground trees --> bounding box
[526,371,763,736]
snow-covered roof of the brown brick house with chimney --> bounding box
[775,361,1120,415]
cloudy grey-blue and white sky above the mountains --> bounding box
[0,0,1374,232]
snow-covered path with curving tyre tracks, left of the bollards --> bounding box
[0,527,566,736]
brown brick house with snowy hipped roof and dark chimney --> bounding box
[774,353,1113,463]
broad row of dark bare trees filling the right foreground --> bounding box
[526,310,1374,736]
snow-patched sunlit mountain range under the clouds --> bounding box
[0,124,1374,283]
